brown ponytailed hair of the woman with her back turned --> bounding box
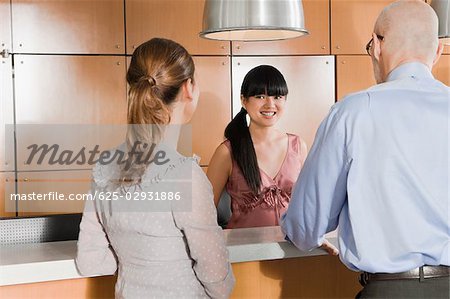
[120,38,195,186]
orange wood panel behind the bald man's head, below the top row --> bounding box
[336,55,450,100]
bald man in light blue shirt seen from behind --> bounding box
[281,0,450,299]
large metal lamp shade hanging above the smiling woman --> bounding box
[200,0,308,41]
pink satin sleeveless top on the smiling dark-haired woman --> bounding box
[223,134,306,228]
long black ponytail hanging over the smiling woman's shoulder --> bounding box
[225,108,261,194]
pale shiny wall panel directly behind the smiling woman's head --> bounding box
[233,56,335,149]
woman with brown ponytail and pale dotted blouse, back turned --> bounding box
[76,38,234,298]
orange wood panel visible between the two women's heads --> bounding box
[191,57,231,165]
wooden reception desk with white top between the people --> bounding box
[0,227,360,298]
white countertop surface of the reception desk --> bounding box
[0,226,337,286]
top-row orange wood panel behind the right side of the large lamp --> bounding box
[232,0,330,55]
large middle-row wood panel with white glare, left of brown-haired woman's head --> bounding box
[15,55,127,175]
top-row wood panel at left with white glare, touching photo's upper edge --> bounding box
[12,0,125,54]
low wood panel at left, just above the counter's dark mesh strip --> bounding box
[17,170,92,216]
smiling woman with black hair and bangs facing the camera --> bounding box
[208,65,307,228]
